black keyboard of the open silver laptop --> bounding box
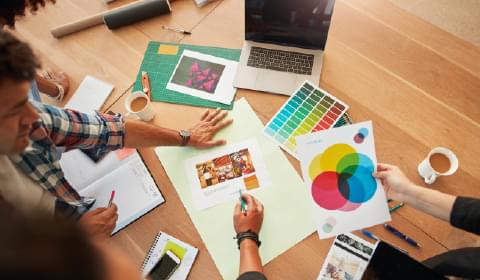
[247,47,315,75]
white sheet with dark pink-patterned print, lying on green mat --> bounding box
[167,50,238,104]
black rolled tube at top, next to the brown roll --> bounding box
[103,0,171,29]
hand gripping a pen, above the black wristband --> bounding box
[233,194,263,234]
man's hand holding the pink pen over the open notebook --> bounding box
[80,203,118,237]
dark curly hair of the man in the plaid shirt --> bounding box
[0,30,40,83]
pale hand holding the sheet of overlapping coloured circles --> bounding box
[373,163,415,202]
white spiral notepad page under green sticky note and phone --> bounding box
[142,232,198,280]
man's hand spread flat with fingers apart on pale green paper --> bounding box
[188,109,233,149]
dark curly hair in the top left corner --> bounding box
[0,0,56,27]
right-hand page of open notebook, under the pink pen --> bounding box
[79,153,165,233]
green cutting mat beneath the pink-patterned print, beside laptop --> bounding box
[133,41,240,110]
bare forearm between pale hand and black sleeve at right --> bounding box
[405,185,456,222]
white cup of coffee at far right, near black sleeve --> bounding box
[417,147,458,184]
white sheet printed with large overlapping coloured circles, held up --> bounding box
[297,121,391,239]
